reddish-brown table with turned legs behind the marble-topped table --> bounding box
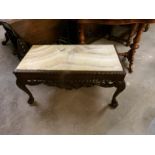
[78,19,155,72]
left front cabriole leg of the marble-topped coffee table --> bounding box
[16,79,34,104]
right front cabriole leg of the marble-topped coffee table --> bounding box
[109,80,126,109]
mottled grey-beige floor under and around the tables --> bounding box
[0,25,155,134]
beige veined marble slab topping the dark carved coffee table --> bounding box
[17,45,123,71]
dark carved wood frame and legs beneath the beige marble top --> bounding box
[14,70,125,108]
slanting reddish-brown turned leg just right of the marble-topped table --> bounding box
[128,24,146,73]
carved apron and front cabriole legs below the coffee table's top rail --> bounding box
[16,78,125,108]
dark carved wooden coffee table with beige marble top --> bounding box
[14,45,126,108]
